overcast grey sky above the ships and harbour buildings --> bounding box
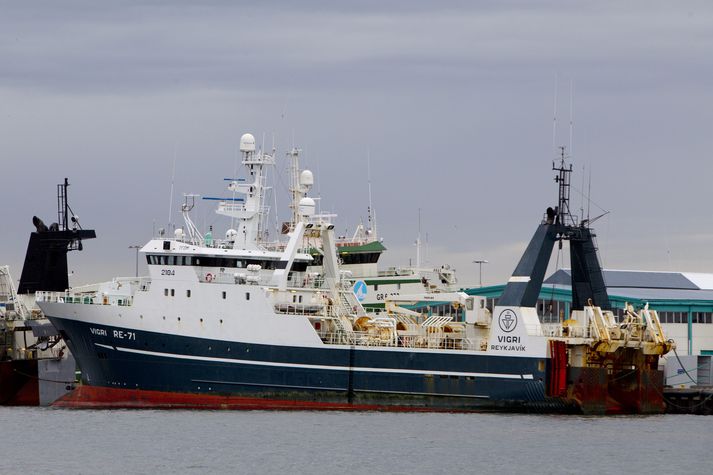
[0,0,713,284]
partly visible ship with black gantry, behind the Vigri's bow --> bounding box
[0,178,96,406]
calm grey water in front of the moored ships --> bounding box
[0,407,713,475]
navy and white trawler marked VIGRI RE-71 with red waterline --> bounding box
[38,138,671,414]
